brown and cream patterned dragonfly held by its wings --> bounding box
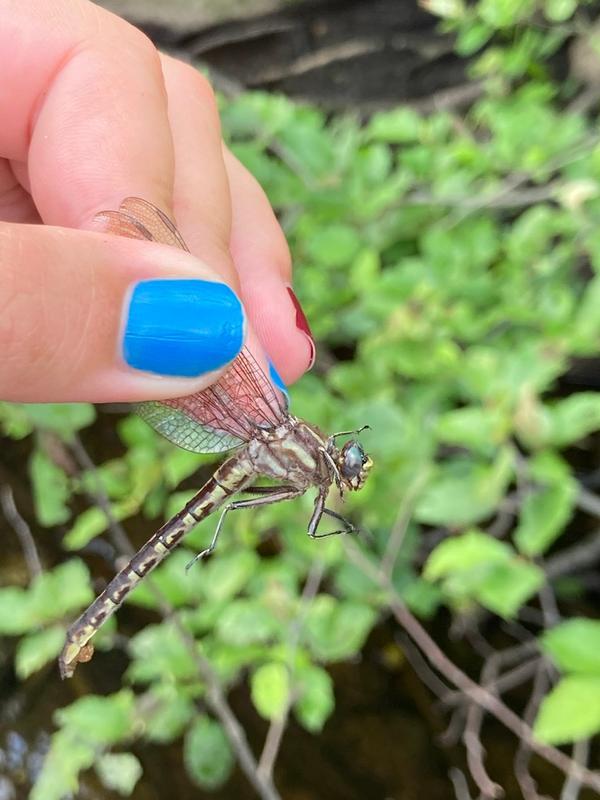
[59,197,372,678]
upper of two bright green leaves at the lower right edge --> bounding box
[540,617,600,676]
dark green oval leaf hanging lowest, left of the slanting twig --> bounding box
[183,716,234,789]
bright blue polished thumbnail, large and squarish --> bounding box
[123,279,244,378]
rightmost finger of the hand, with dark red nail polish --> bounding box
[225,150,315,383]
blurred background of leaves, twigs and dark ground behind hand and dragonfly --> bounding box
[0,0,600,800]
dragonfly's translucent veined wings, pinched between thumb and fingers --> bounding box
[97,197,287,453]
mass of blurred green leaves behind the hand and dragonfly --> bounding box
[0,0,600,788]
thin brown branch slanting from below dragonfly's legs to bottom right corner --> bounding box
[347,540,600,790]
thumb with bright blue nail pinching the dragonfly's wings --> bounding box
[0,223,245,402]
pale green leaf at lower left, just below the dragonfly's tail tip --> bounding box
[56,690,135,745]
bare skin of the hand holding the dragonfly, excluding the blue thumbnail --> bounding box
[0,0,310,402]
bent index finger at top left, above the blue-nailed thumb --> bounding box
[0,0,173,227]
